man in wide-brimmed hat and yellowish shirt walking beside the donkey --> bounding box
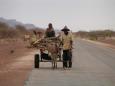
[61,26,73,68]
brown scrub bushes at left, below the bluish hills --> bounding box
[0,22,43,39]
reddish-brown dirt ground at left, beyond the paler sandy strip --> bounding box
[0,40,33,68]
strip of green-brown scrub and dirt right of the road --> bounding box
[75,30,115,46]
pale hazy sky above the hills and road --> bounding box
[0,0,115,31]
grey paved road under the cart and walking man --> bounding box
[25,40,115,86]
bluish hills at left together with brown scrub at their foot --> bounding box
[0,17,44,39]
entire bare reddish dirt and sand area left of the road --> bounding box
[0,41,35,86]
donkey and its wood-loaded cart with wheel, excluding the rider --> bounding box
[34,37,63,69]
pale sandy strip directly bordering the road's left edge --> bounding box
[0,51,35,86]
